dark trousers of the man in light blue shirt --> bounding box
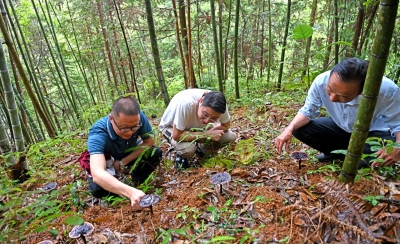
[293,117,396,157]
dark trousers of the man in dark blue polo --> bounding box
[88,146,162,198]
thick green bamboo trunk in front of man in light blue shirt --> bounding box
[339,0,399,183]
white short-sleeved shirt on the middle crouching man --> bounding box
[158,89,230,130]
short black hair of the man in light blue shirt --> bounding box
[330,58,368,94]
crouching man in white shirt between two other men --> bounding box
[159,89,236,168]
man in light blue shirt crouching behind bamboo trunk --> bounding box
[275,58,400,167]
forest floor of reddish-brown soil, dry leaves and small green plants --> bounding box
[19,97,400,244]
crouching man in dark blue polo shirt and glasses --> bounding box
[88,97,162,208]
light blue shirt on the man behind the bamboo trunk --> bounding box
[299,71,400,136]
